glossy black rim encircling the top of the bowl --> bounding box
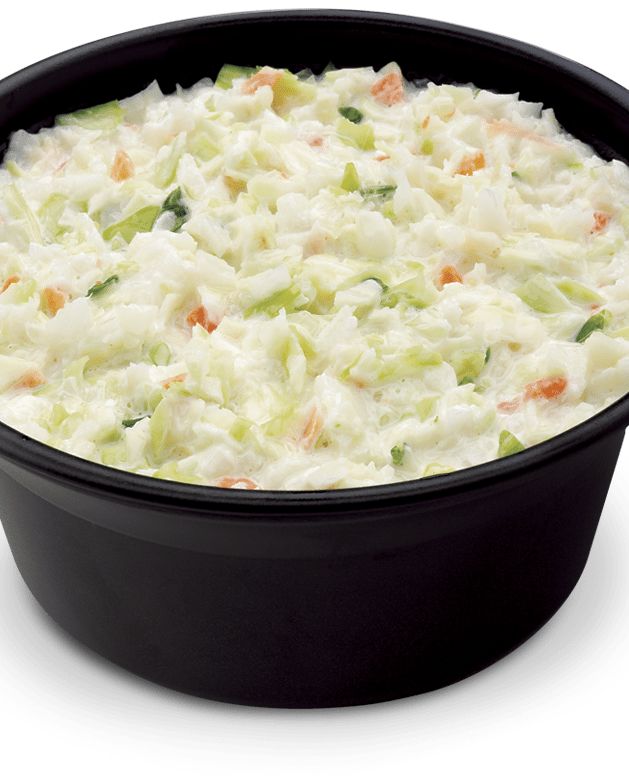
[0,9,629,520]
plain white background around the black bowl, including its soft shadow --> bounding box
[0,0,629,779]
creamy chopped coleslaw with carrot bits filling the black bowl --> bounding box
[0,64,629,490]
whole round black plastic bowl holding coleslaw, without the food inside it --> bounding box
[0,11,629,707]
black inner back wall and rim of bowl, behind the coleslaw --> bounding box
[0,11,629,161]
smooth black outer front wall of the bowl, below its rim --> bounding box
[0,426,622,707]
